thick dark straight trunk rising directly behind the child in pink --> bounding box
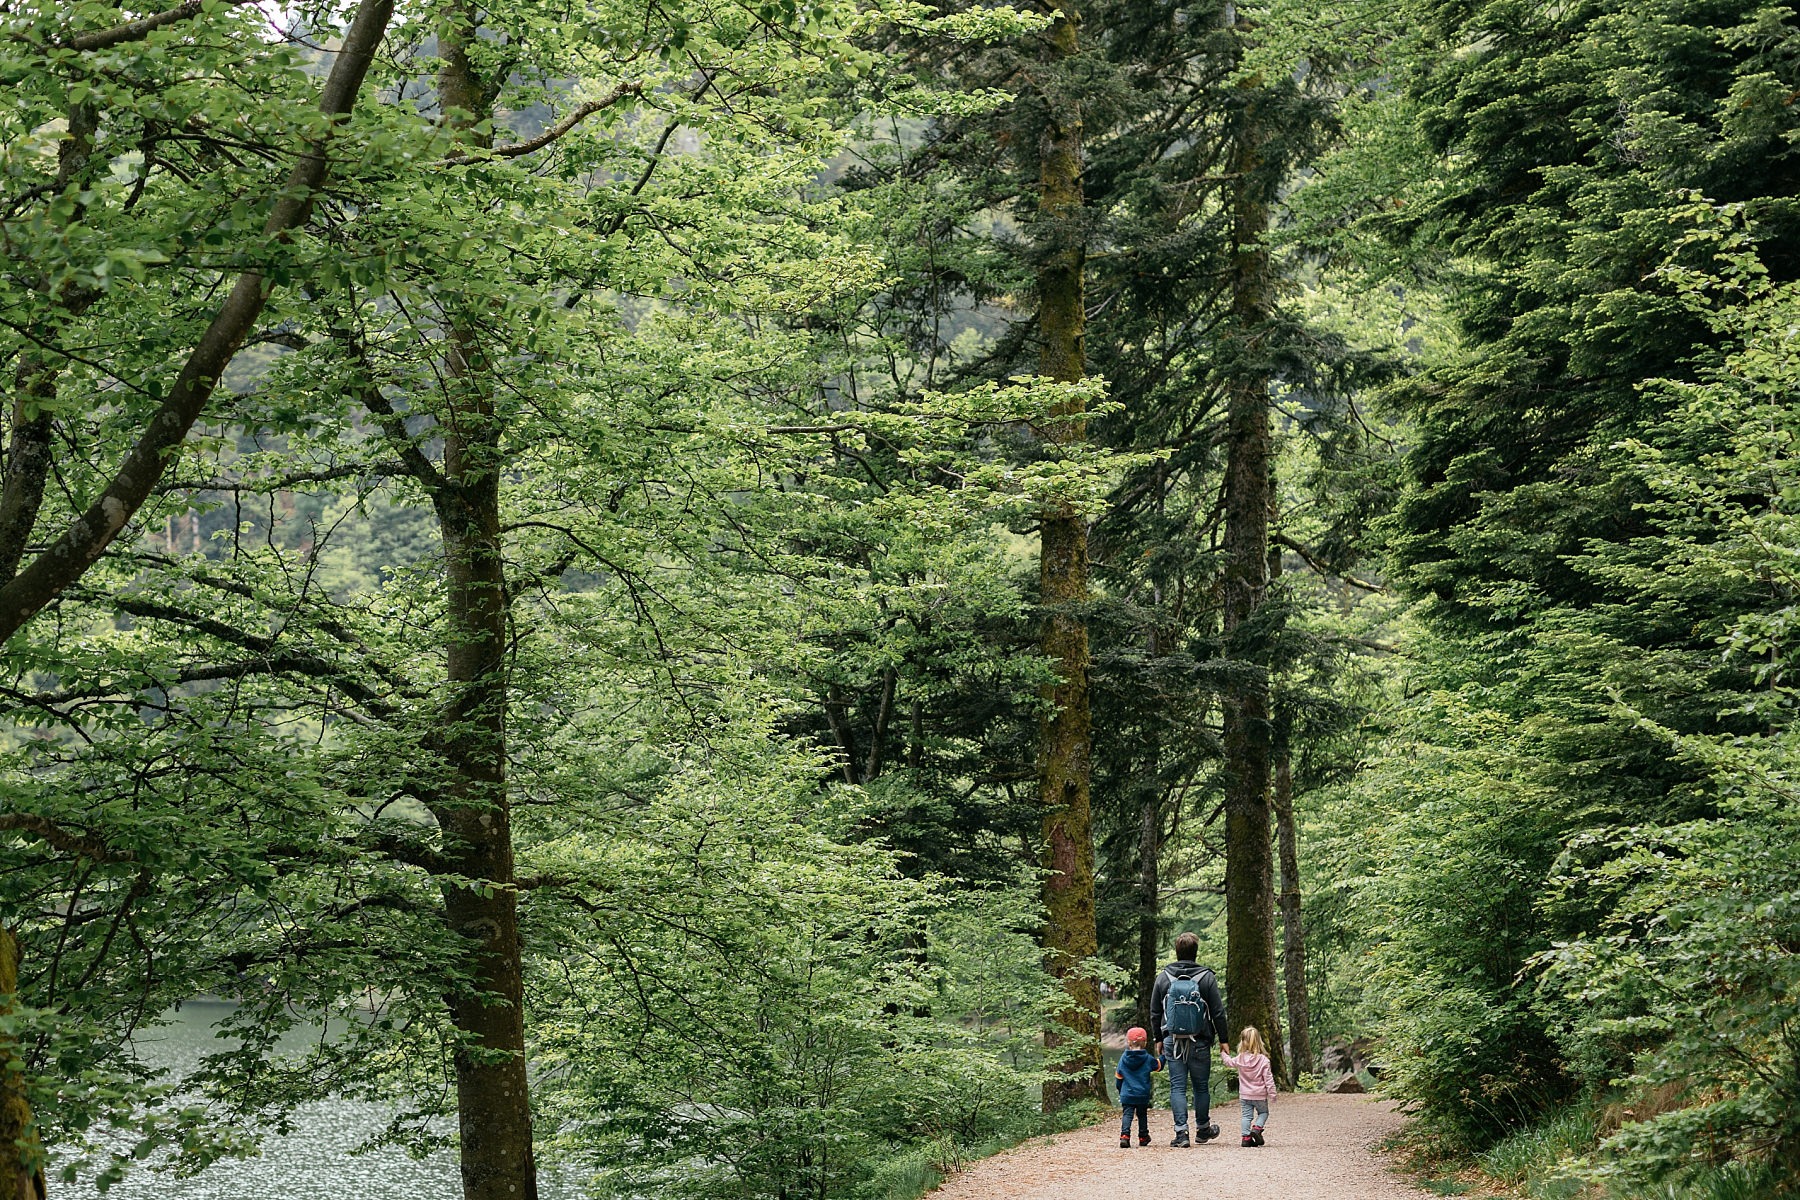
[1224,39,1285,1078]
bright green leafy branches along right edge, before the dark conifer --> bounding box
[1541,205,1800,1186]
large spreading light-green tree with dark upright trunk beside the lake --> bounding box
[0,4,1094,1196]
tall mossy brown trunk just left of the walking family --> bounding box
[1037,0,1107,1112]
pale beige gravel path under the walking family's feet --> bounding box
[931,1094,1431,1200]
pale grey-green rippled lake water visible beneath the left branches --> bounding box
[50,1000,532,1200]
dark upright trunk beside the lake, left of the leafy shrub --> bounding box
[432,21,538,1200]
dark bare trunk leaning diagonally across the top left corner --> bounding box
[0,0,394,642]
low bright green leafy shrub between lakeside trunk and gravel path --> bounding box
[522,759,1058,1196]
